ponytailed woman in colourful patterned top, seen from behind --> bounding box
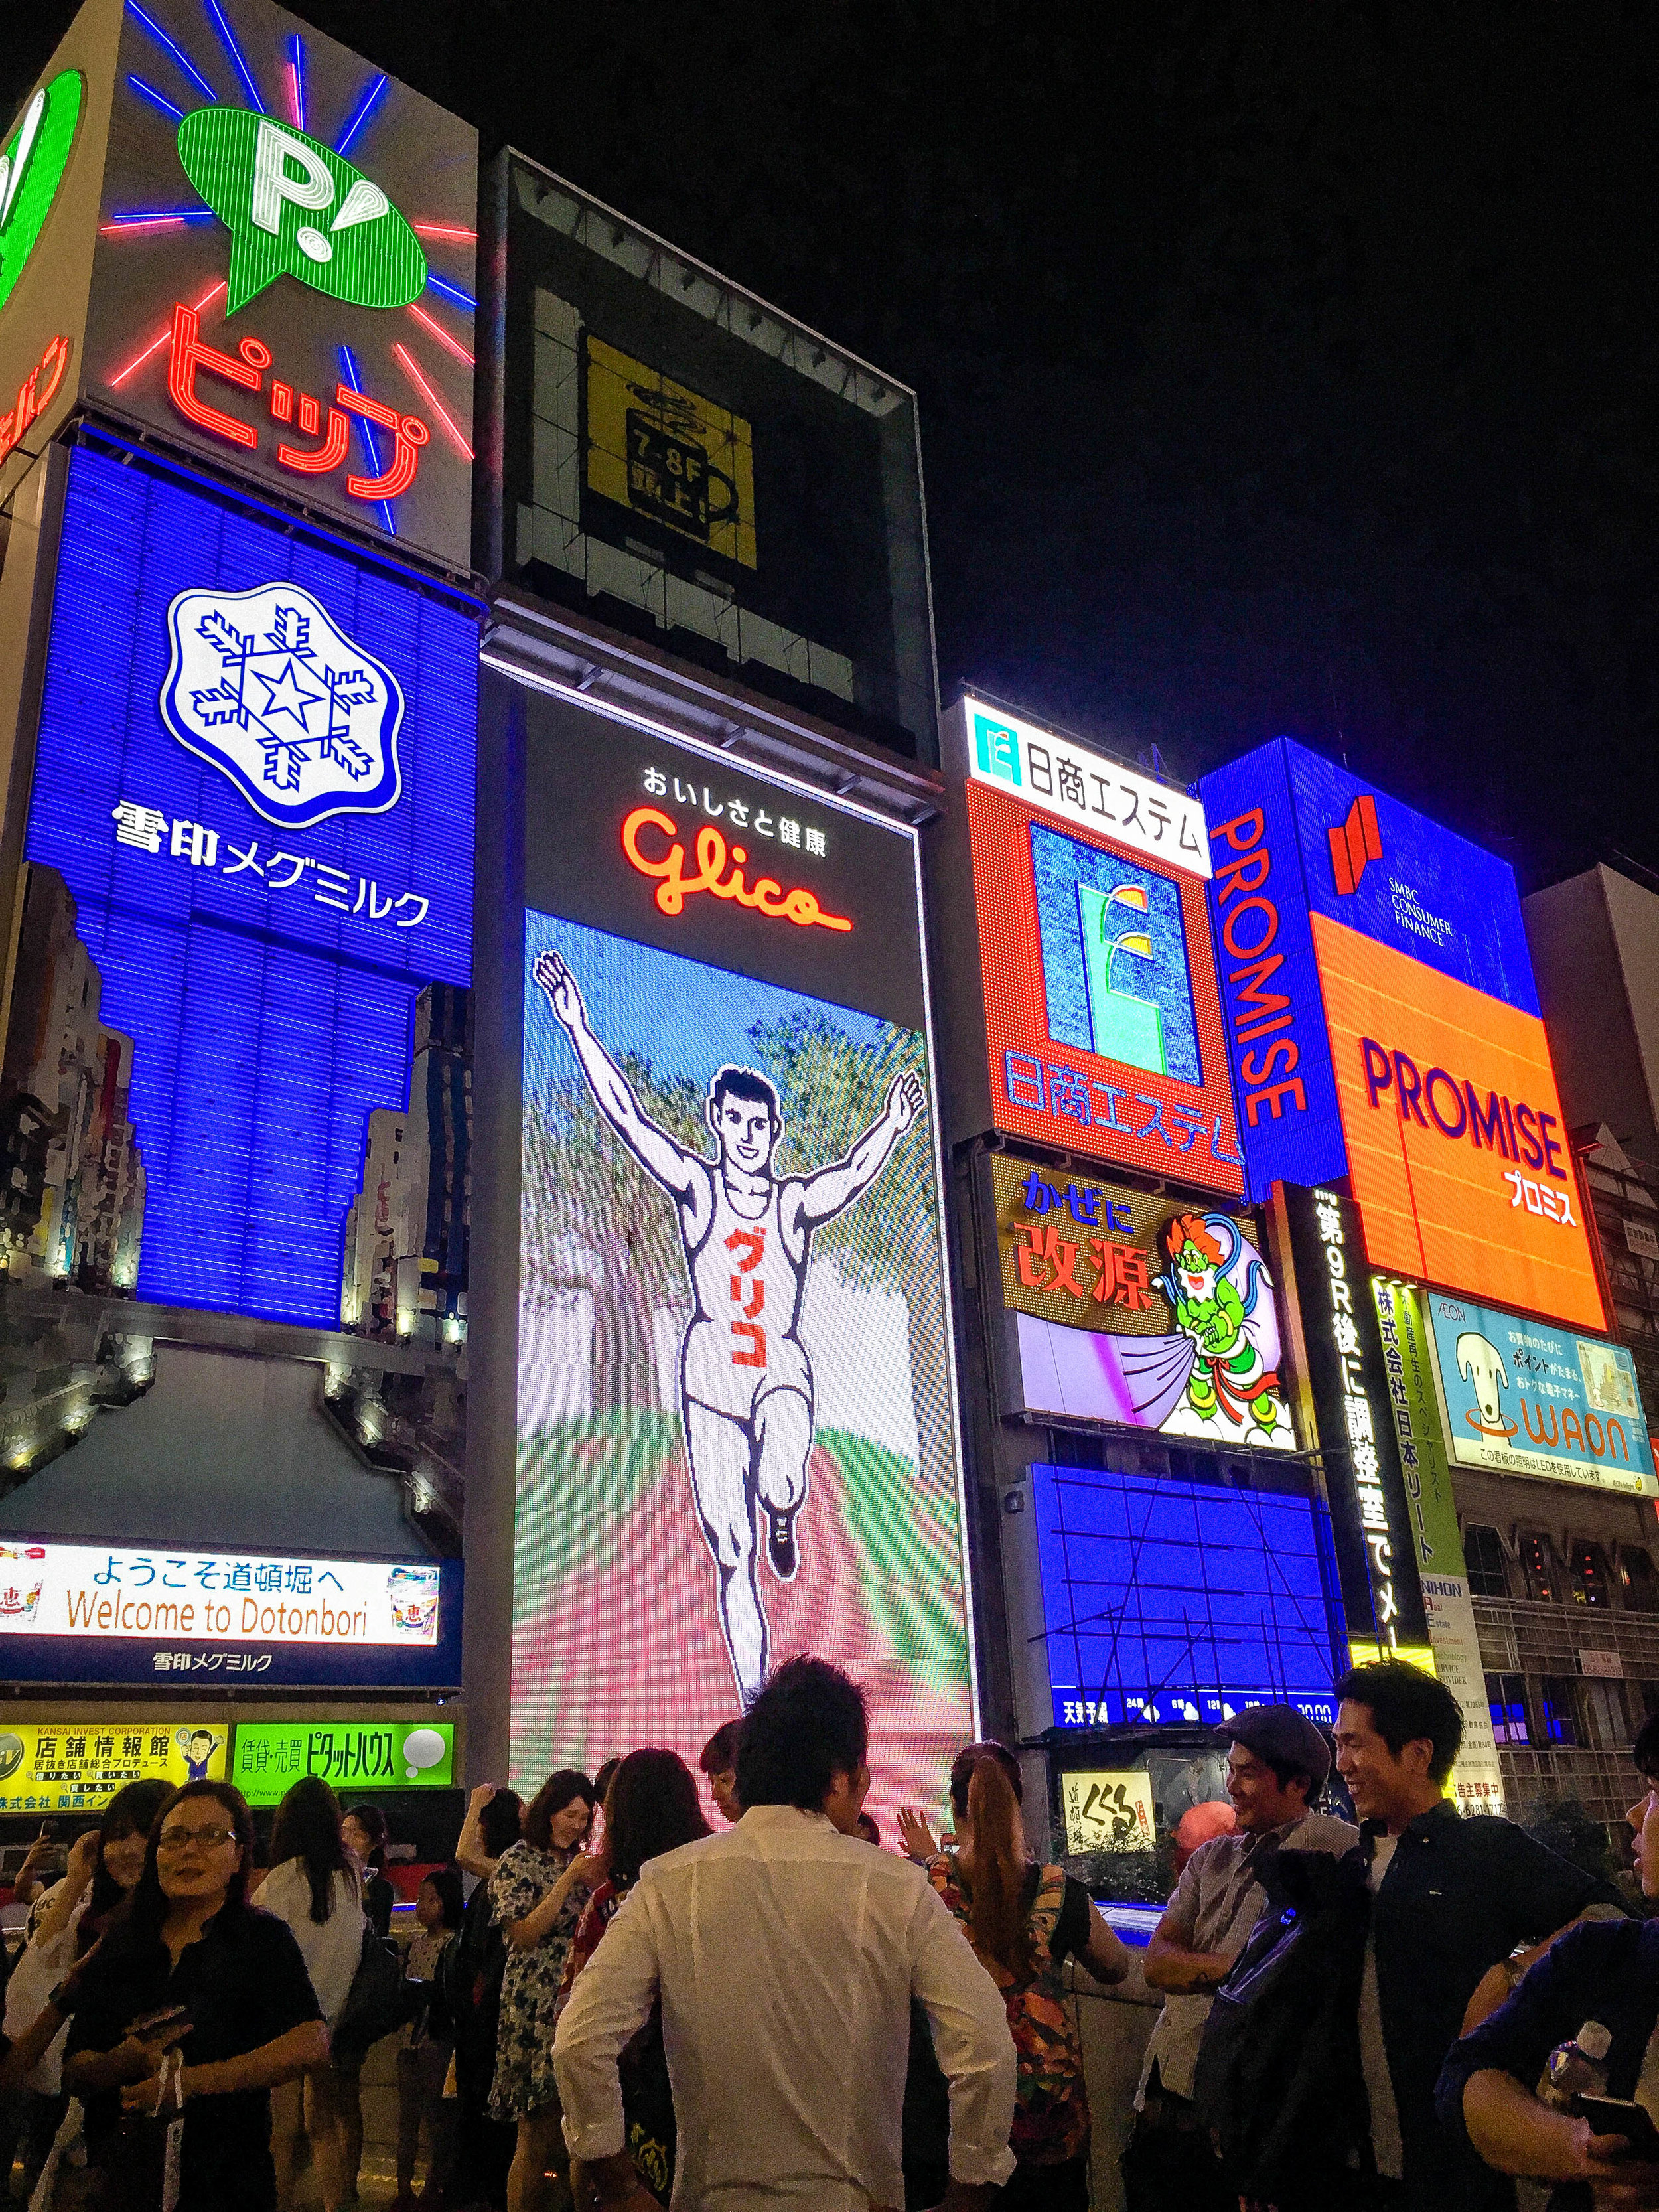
[898,1743,1128,2212]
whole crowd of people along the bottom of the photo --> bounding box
[0,1657,1659,2212]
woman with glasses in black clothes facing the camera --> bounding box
[64,1783,327,2212]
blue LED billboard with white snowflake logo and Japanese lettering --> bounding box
[19,447,478,1327]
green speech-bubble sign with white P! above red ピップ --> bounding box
[179,108,427,314]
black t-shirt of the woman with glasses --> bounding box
[66,1905,323,2212]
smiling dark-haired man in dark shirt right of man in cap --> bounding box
[1336,1659,1619,2212]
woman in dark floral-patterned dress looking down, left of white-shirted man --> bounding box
[489,1767,599,2212]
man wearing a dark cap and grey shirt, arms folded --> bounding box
[1123,1706,1360,2212]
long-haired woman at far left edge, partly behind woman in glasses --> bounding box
[5,1781,173,2194]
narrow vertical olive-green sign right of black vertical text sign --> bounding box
[1372,1276,1504,1812]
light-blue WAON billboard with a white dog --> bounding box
[1422,1291,1659,1497]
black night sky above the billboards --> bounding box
[13,0,1659,887]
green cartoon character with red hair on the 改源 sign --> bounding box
[1157,1215,1285,1438]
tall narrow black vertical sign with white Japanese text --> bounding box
[1283,1185,1427,1657]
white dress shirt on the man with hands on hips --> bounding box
[553,1805,1015,2212]
